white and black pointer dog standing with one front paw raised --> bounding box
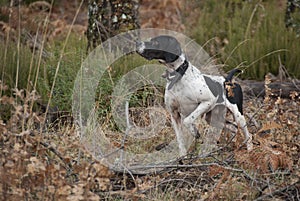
[137,35,253,156]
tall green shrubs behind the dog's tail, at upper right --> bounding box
[191,0,300,79]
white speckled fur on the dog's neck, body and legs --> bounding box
[165,54,252,156]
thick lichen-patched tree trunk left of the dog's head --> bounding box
[87,0,140,51]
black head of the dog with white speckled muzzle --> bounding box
[137,35,182,63]
